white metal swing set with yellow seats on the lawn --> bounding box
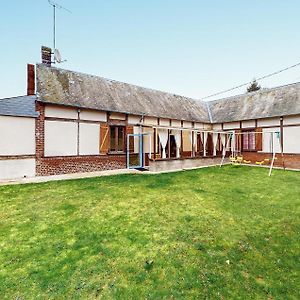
[220,131,285,176]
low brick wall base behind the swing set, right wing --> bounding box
[243,152,300,170]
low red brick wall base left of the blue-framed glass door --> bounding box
[36,155,126,176]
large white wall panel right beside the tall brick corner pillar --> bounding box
[45,121,78,156]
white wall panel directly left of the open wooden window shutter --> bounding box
[79,123,100,155]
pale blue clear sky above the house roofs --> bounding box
[0,0,300,100]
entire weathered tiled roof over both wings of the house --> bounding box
[37,64,300,123]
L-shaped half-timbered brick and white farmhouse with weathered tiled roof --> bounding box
[0,64,300,179]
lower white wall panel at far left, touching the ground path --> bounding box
[0,158,35,180]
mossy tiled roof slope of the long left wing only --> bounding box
[37,64,209,123]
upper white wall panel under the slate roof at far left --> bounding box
[0,116,35,156]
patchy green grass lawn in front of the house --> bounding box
[0,166,300,299]
